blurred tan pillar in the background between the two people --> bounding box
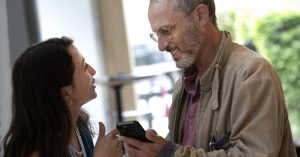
[94,0,135,124]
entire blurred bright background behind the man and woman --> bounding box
[0,0,300,156]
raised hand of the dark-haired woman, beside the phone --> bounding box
[94,122,122,157]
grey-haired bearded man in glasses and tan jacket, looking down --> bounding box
[121,0,296,157]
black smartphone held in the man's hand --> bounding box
[117,120,152,142]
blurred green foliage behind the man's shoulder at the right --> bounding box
[254,13,300,138]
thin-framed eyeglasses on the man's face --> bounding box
[150,18,185,43]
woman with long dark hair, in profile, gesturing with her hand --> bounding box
[4,37,121,157]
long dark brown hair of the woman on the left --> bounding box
[4,37,91,157]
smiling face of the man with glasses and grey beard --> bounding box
[148,0,203,68]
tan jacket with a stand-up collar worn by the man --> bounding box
[168,32,296,157]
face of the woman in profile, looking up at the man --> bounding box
[67,45,97,106]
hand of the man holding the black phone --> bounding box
[120,130,166,157]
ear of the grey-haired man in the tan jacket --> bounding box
[192,4,210,26]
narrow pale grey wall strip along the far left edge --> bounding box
[0,0,11,156]
